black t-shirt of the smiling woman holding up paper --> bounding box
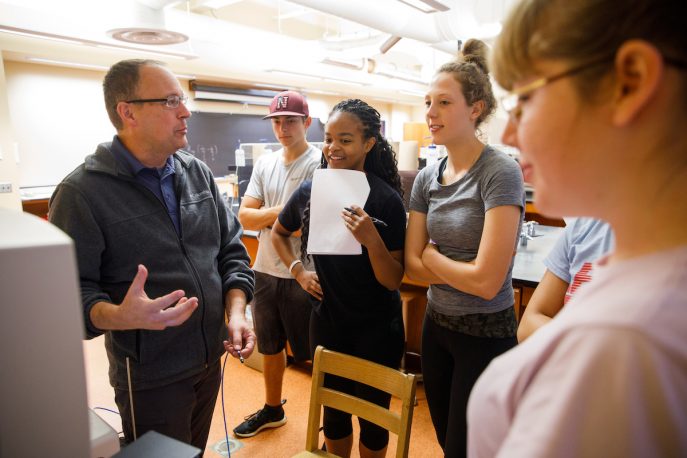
[279,173,406,329]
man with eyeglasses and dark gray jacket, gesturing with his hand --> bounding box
[49,59,255,450]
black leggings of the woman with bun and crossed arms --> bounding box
[422,315,517,458]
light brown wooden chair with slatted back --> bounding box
[295,346,416,458]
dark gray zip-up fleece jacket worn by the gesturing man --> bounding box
[49,143,254,390]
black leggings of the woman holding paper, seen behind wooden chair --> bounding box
[310,311,405,450]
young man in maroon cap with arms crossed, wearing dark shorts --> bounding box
[234,91,322,437]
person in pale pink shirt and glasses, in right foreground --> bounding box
[468,0,687,458]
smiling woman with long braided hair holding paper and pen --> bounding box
[272,99,406,457]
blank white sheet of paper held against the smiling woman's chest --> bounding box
[308,169,370,254]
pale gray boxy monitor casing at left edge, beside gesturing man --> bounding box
[0,209,91,458]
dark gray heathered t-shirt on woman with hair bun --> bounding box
[410,145,525,316]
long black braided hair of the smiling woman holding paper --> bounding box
[301,99,403,260]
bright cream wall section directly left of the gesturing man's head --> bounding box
[5,61,115,187]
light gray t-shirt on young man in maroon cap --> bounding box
[245,145,322,278]
